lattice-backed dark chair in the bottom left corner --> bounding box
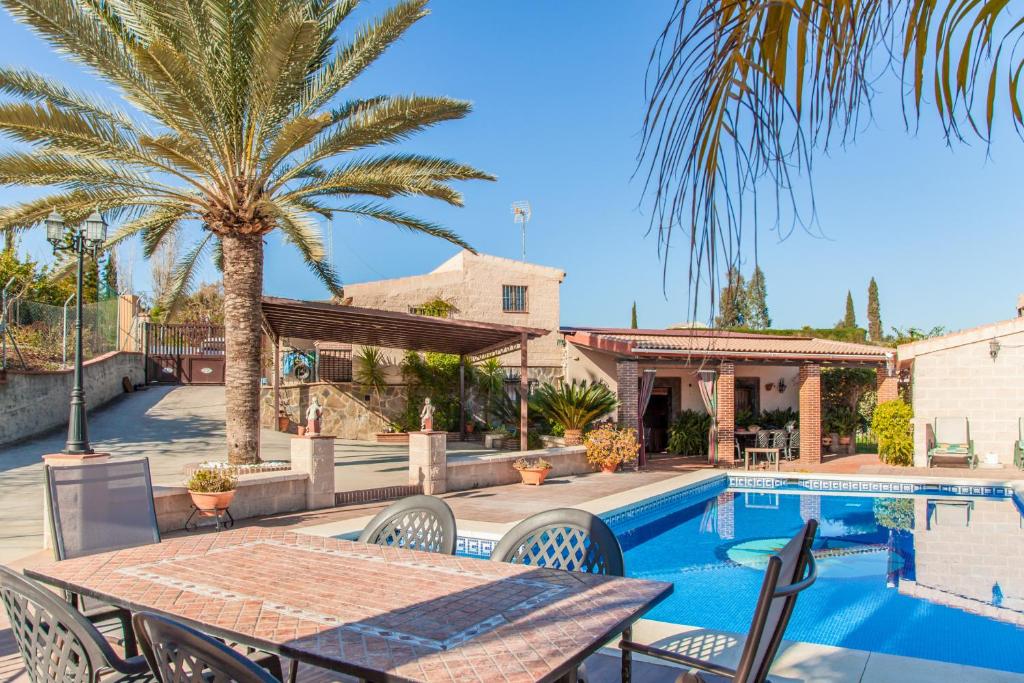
[0,566,154,683]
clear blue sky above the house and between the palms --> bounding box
[0,0,1024,329]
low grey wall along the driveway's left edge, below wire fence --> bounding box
[0,351,144,444]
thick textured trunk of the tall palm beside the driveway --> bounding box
[221,233,263,464]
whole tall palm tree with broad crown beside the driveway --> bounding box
[0,0,493,462]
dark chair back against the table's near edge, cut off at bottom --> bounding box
[131,612,280,683]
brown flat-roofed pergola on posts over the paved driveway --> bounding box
[262,297,549,451]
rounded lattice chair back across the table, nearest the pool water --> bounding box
[490,508,625,577]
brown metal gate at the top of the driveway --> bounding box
[143,323,224,384]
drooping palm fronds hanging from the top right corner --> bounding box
[639,0,1024,313]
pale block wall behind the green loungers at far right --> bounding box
[897,318,1024,467]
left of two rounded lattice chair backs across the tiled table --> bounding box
[359,496,458,555]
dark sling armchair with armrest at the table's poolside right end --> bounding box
[618,519,818,683]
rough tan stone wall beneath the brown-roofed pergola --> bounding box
[260,382,406,440]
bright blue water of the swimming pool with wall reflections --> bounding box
[608,483,1024,673]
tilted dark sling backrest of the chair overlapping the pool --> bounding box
[734,519,818,683]
